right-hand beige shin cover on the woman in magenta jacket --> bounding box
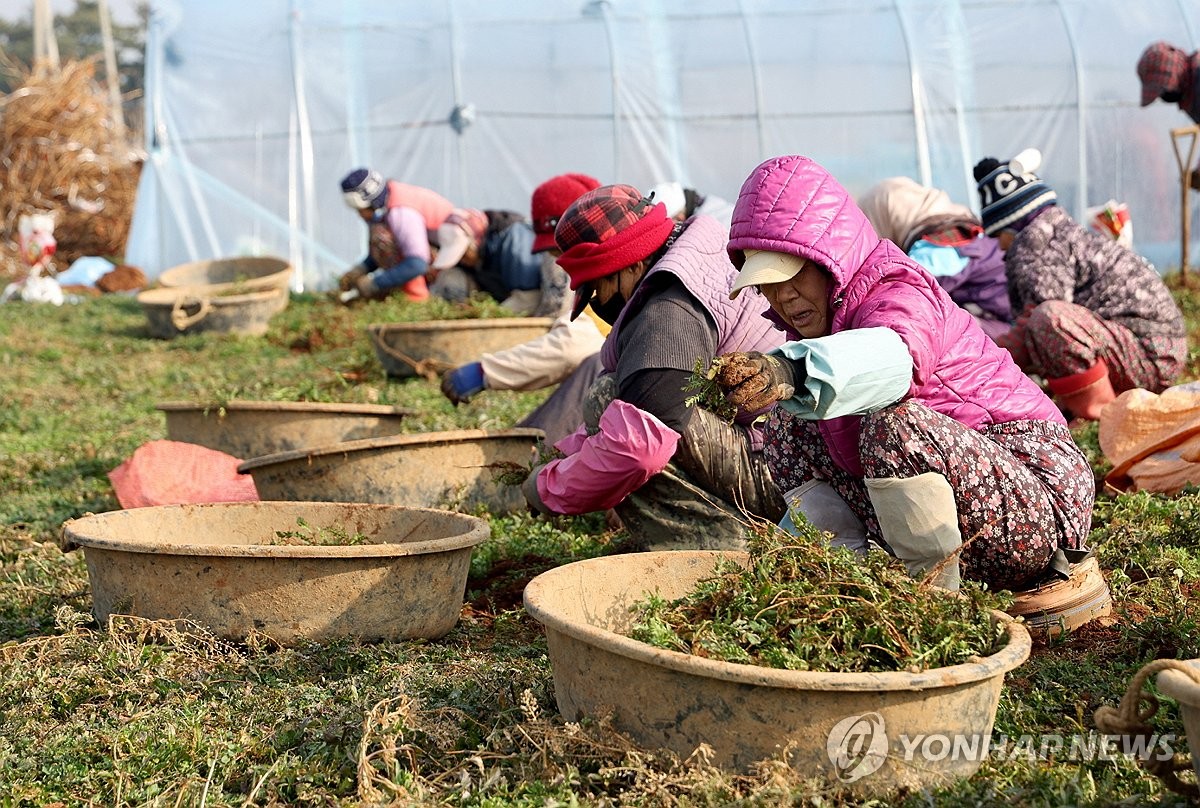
[864,472,962,591]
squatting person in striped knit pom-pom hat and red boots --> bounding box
[974,149,1188,420]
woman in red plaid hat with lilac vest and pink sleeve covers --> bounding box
[523,185,784,549]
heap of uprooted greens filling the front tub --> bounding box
[629,516,1007,672]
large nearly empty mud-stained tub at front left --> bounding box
[62,502,488,644]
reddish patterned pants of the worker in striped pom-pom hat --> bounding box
[1021,300,1187,393]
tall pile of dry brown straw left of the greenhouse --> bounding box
[0,60,140,276]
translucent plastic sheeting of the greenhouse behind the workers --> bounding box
[126,0,1200,291]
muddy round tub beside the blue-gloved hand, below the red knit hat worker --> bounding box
[366,317,554,378]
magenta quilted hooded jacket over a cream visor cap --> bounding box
[728,155,1063,474]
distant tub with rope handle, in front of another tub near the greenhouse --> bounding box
[137,286,287,340]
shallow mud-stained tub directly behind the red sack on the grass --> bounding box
[157,401,413,460]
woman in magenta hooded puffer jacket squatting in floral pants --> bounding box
[718,156,1096,589]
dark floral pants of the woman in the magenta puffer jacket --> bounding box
[764,401,1096,591]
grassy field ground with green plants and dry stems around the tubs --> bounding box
[0,286,1200,807]
